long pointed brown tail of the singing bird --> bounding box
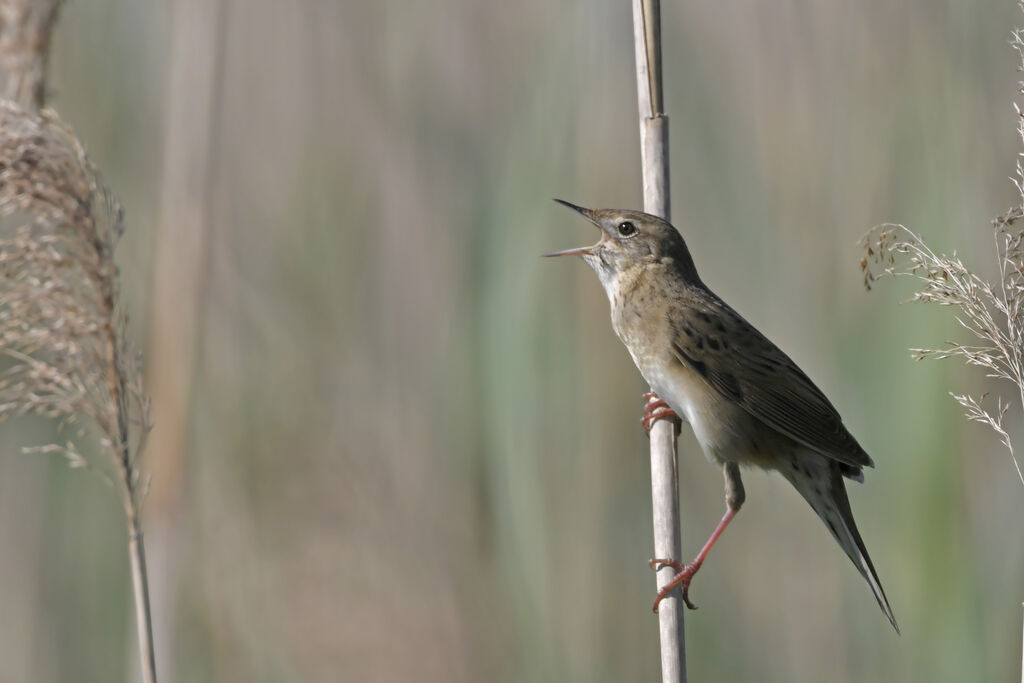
[779,453,899,633]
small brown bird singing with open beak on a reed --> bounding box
[545,200,899,633]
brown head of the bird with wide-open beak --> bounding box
[545,200,700,290]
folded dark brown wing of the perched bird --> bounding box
[671,293,873,475]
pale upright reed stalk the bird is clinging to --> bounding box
[633,0,686,683]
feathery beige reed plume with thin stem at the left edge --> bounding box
[0,101,156,683]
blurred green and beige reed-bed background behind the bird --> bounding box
[0,0,1024,682]
